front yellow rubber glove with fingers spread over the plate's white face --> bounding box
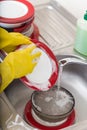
[0,44,41,92]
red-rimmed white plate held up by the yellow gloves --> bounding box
[19,40,58,91]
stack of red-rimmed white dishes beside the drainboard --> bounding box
[0,0,34,36]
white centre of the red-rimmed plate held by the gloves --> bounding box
[26,48,52,84]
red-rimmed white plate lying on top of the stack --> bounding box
[0,0,34,24]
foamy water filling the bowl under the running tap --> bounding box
[35,89,73,115]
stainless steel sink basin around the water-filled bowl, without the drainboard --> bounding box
[5,55,87,129]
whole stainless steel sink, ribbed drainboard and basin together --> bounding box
[0,0,87,130]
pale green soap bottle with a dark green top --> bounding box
[74,11,87,56]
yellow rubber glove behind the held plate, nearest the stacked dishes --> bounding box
[0,27,32,53]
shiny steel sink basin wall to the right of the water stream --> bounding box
[58,55,87,122]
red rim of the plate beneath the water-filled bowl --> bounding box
[24,100,75,130]
